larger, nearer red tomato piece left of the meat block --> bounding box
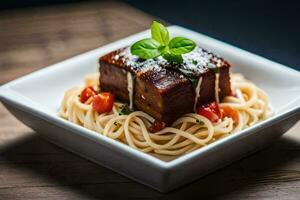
[92,92,115,114]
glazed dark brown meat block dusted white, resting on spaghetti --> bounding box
[99,47,231,125]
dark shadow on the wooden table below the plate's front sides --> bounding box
[0,129,300,199]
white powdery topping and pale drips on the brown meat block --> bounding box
[108,47,222,110]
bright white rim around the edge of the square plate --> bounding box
[0,25,300,169]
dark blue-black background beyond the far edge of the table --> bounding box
[0,0,300,70]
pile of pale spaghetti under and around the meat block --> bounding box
[59,74,272,156]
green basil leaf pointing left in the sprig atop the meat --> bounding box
[130,38,162,59]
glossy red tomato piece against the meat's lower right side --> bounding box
[197,102,222,122]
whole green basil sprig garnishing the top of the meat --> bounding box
[130,21,196,63]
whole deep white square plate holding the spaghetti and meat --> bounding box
[0,26,300,192]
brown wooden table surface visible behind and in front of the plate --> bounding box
[0,2,300,200]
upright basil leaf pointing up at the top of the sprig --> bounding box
[151,21,170,45]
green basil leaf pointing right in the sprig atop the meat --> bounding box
[169,37,196,55]
